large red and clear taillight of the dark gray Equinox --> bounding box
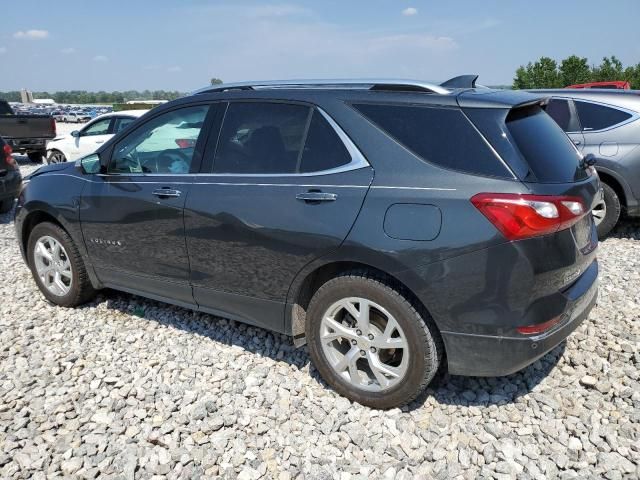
[471,193,587,240]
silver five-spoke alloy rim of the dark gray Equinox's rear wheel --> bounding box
[320,297,409,392]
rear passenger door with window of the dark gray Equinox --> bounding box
[185,101,373,331]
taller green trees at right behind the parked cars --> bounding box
[513,55,640,89]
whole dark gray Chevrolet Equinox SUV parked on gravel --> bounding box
[15,77,600,408]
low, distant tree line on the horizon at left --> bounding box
[0,90,185,104]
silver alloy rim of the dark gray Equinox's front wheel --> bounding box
[33,236,73,297]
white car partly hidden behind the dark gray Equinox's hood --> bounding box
[47,110,147,163]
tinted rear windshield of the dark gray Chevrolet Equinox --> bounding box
[506,105,587,183]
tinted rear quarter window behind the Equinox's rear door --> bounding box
[353,104,512,178]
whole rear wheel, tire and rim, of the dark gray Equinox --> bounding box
[306,273,444,409]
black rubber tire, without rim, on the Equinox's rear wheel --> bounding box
[306,272,444,409]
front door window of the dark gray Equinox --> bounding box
[109,105,209,174]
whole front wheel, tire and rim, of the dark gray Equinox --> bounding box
[27,222,95,307]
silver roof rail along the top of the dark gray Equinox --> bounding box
[193,79,451,95]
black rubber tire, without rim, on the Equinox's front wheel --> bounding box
[27,222,96,307]
